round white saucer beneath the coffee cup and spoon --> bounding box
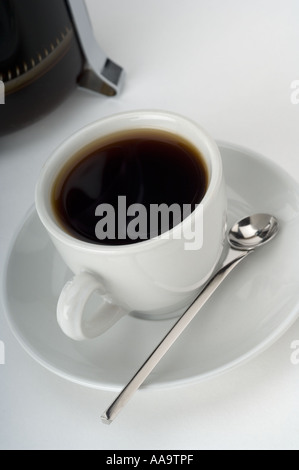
[4,144,299,391]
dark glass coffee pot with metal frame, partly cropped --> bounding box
[0,0,124,135]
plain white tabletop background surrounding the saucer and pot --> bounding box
[0,0,299,450]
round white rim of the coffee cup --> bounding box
[35,109,223,254]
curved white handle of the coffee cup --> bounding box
[57,272,128,341]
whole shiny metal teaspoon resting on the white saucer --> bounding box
[101,214,279,424]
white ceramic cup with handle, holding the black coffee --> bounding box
[36,110,227,340]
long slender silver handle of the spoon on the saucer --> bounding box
[101,248,251,424]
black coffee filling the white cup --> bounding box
[52,130,208,245]
